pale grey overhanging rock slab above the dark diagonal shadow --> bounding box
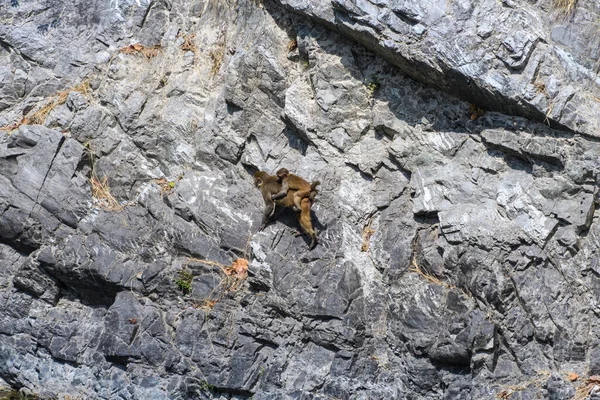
[279,0,600,137]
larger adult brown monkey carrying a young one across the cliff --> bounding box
[254,171,317,249]
